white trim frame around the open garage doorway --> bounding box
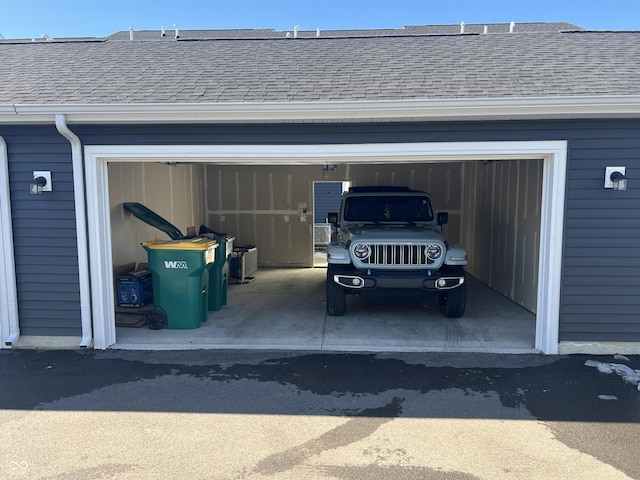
[81,140,567,354]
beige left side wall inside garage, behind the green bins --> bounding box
[108,162,206,272]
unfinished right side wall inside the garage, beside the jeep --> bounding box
[462,160,543,313]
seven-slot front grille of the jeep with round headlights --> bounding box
[352,243,443,267]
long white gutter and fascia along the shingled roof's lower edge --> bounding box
[0,95,640,124]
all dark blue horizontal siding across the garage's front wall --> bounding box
[0,119,640,342]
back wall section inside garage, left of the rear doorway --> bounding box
[207,165,322,267]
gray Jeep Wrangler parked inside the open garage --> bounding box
[326,187,467,318]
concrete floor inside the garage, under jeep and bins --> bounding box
[114,268,536,353]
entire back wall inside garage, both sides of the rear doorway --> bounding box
[207,163,462,267]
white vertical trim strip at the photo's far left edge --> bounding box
[0,137,20,348]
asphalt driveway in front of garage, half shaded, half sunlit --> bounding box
[0,350,640,480]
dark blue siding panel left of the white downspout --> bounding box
[0,127,81,335]
